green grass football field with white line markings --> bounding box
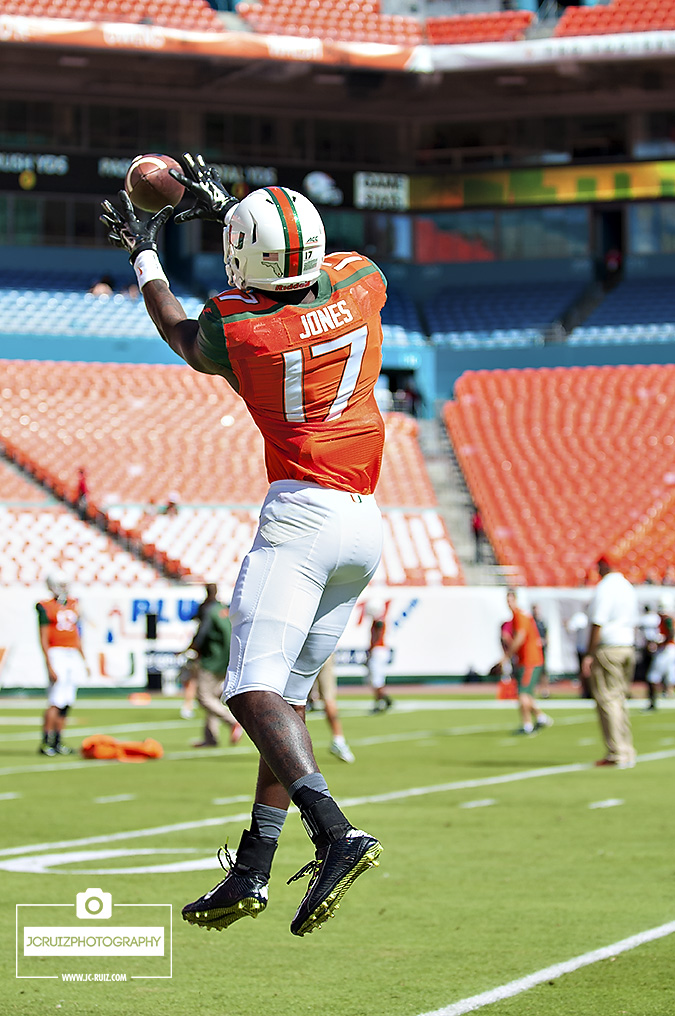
[0,689,675,1016]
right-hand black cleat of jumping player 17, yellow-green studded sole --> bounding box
[289,829,382,935]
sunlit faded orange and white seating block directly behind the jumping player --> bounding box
[0,361,464,585]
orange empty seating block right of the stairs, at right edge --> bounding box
[443,365,675,586]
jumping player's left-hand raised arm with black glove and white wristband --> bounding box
[101,190,221,374]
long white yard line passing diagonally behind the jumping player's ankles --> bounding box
[0,750,675,858]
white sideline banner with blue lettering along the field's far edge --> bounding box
[0,584,668,690]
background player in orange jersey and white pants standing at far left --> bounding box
[36,573,88,756]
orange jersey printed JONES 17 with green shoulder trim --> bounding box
[199,253,386,494]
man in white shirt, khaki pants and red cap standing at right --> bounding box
[581,556,638,769]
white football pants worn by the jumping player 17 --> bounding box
[223,481,382,705]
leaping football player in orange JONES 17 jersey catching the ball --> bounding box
[102,154,386,936]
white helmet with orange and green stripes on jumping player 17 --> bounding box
[223,187,325,293]
